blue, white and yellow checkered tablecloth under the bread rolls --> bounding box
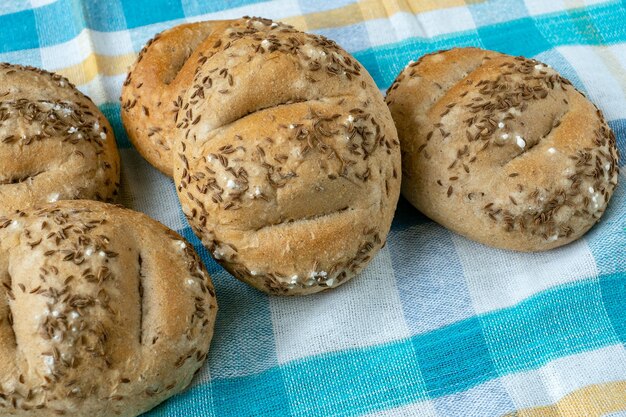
[0,0,626,417]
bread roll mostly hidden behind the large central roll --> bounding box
[121,21,228,177]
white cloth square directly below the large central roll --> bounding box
[270,247,409,364]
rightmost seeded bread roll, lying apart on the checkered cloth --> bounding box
[387,48,618,251]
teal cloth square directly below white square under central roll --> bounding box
[282,340,426,417]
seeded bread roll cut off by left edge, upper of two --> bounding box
[0,64,120,216]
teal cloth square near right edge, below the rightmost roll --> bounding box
[482,279,623,375]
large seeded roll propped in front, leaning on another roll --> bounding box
[163,18,400,295]
